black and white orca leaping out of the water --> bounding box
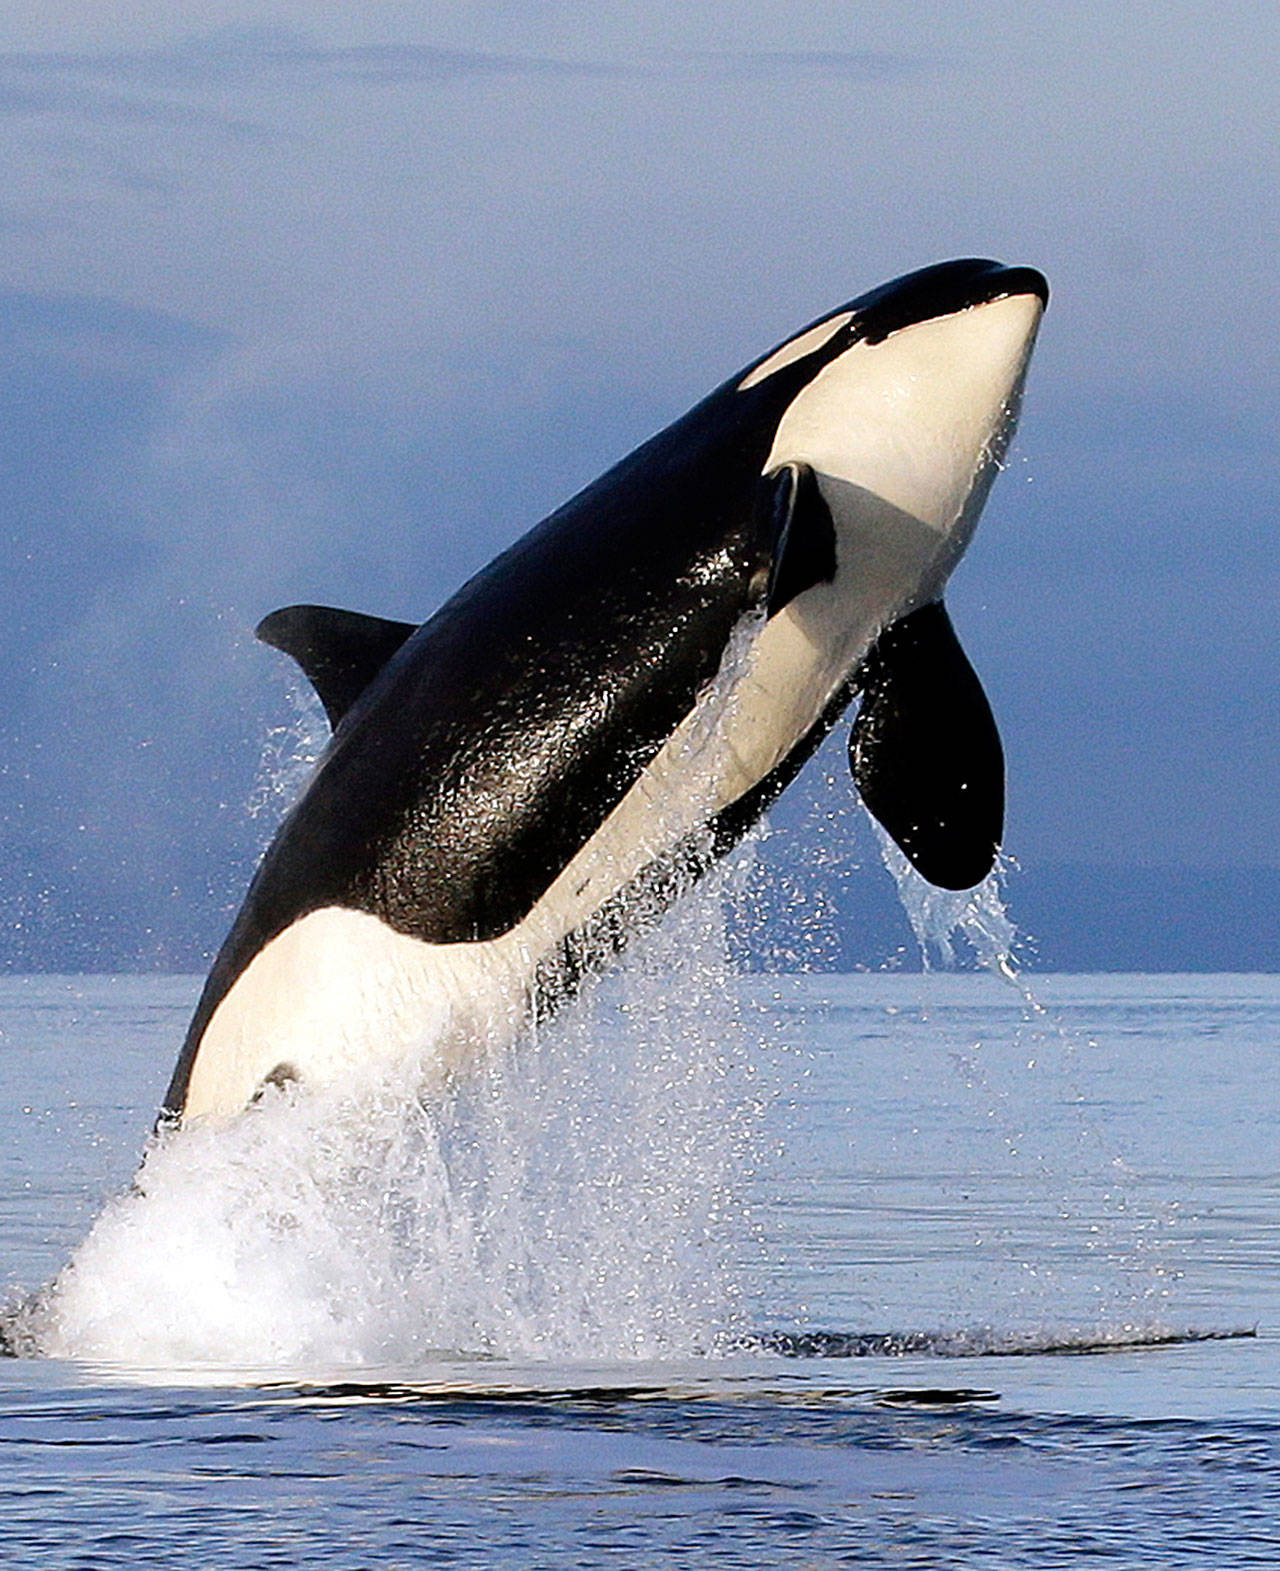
[162,261,1048,1122]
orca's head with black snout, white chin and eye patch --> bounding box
[735,259,1049,602]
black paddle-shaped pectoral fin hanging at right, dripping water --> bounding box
[850,602,1005,889]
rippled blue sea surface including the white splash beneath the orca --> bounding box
[0,965,1280,1568]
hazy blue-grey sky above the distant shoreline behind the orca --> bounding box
[0,0,1280,955]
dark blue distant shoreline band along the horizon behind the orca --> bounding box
[0,854,1280,976]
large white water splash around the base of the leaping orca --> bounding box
[33,880,759,1368]
